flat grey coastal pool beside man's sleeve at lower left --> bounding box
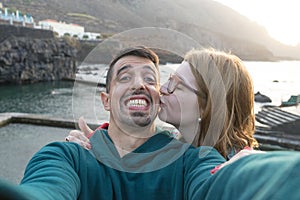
[0,124,70,183]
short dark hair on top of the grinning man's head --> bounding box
[106,46,159,93]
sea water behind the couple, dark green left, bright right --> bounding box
[0,61,300,122]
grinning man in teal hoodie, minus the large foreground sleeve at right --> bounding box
[0,47,224,199]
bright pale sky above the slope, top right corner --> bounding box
[215,0,300,46]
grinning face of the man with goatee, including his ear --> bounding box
[101,56,159,131]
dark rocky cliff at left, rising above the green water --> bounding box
[0,26,77,83]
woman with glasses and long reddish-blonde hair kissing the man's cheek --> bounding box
[66,49,258,159]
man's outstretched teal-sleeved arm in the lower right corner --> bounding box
[188,151,300,199]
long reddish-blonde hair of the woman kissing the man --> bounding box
[185,49,258,157]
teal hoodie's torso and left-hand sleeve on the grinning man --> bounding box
[13,130,225,200]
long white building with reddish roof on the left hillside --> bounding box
[35,19,84,37]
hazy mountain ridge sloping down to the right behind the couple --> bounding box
[2,0,300,60]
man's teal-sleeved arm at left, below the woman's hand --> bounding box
[19,142,83,199]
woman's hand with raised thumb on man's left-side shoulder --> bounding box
[65,117,93,150]
